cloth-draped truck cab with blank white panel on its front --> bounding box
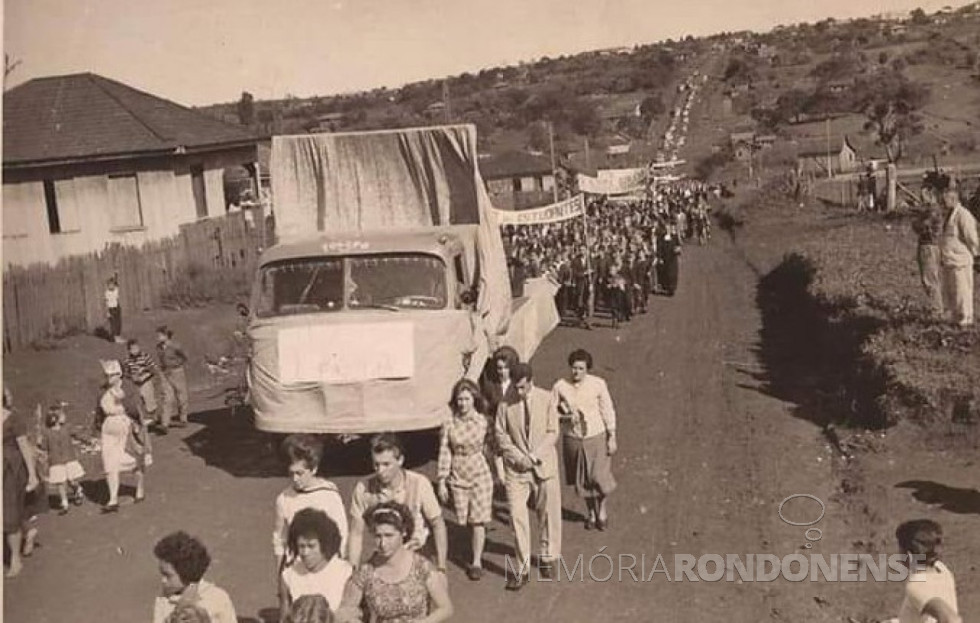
[248,225,488,434]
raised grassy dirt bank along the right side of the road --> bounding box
[719,194,980,620]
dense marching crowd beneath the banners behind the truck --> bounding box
[503,181,715,327]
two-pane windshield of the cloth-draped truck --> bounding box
[254,253,448,318]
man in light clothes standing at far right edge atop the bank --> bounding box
[939,188,980,327]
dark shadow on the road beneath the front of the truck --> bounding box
[184,407,439,478]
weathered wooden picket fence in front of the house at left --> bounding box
[3,208,271,352]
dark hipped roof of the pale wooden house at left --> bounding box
[3,73,256,166]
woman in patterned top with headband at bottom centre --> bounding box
[338,502,453,623]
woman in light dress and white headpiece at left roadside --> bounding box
[99,360,145,513]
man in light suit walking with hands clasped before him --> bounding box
[496,363,561,591]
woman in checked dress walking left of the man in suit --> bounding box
[436,379,493,581]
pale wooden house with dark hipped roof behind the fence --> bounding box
[3,73,261,265]
